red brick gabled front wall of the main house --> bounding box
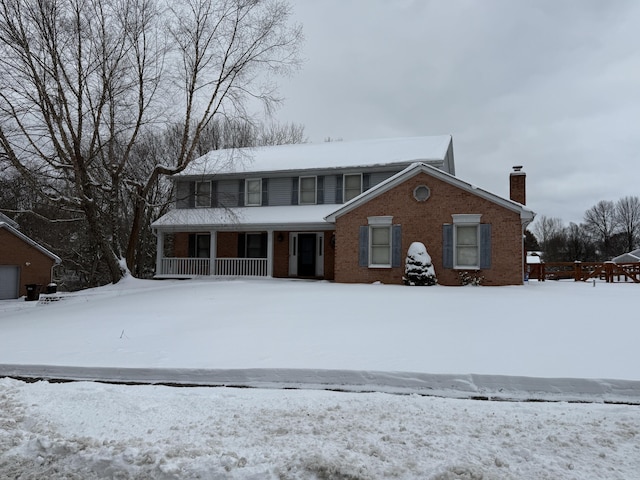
[335,172,522,285]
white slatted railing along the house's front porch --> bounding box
[161,258,269,277]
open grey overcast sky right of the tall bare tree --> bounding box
[276,0,640,223]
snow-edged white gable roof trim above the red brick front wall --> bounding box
[325,162,535,223]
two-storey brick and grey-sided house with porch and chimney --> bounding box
[152,136,535,285]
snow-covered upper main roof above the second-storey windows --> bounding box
[179,135,455,176]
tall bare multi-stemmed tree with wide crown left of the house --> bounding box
[0,0,301,282]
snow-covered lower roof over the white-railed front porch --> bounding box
[151,205,336,231]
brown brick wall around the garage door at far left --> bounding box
[0,228,55,296]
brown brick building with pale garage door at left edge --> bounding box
[0,213,60,300]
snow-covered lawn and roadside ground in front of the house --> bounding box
[0,279,640,479]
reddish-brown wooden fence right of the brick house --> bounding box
[527,262,640,283]
